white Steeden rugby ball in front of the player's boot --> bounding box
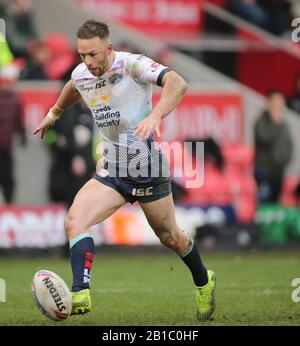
[31,270,72,321]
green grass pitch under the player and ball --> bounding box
[0,251,300,326]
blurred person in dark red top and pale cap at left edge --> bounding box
[0,65,26,203]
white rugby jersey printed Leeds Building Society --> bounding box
[71,52,168,176]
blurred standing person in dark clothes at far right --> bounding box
[255,90,292,203]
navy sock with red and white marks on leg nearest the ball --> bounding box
[70,233,95,292]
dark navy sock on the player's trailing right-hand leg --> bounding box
[180,240,208,287]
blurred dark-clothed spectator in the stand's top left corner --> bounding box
[4,0,37,57]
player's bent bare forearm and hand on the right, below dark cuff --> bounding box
[135,71,187,139]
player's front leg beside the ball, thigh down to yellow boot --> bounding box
[65,179,126,314]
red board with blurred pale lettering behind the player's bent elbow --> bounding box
[153,91,244,143]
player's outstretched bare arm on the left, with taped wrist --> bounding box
[33,80,81,138]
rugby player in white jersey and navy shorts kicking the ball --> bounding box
[34,20,216,321]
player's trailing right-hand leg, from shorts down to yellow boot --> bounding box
[140,194,215,320]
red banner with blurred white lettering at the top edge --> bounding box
[76,0,203,37]
